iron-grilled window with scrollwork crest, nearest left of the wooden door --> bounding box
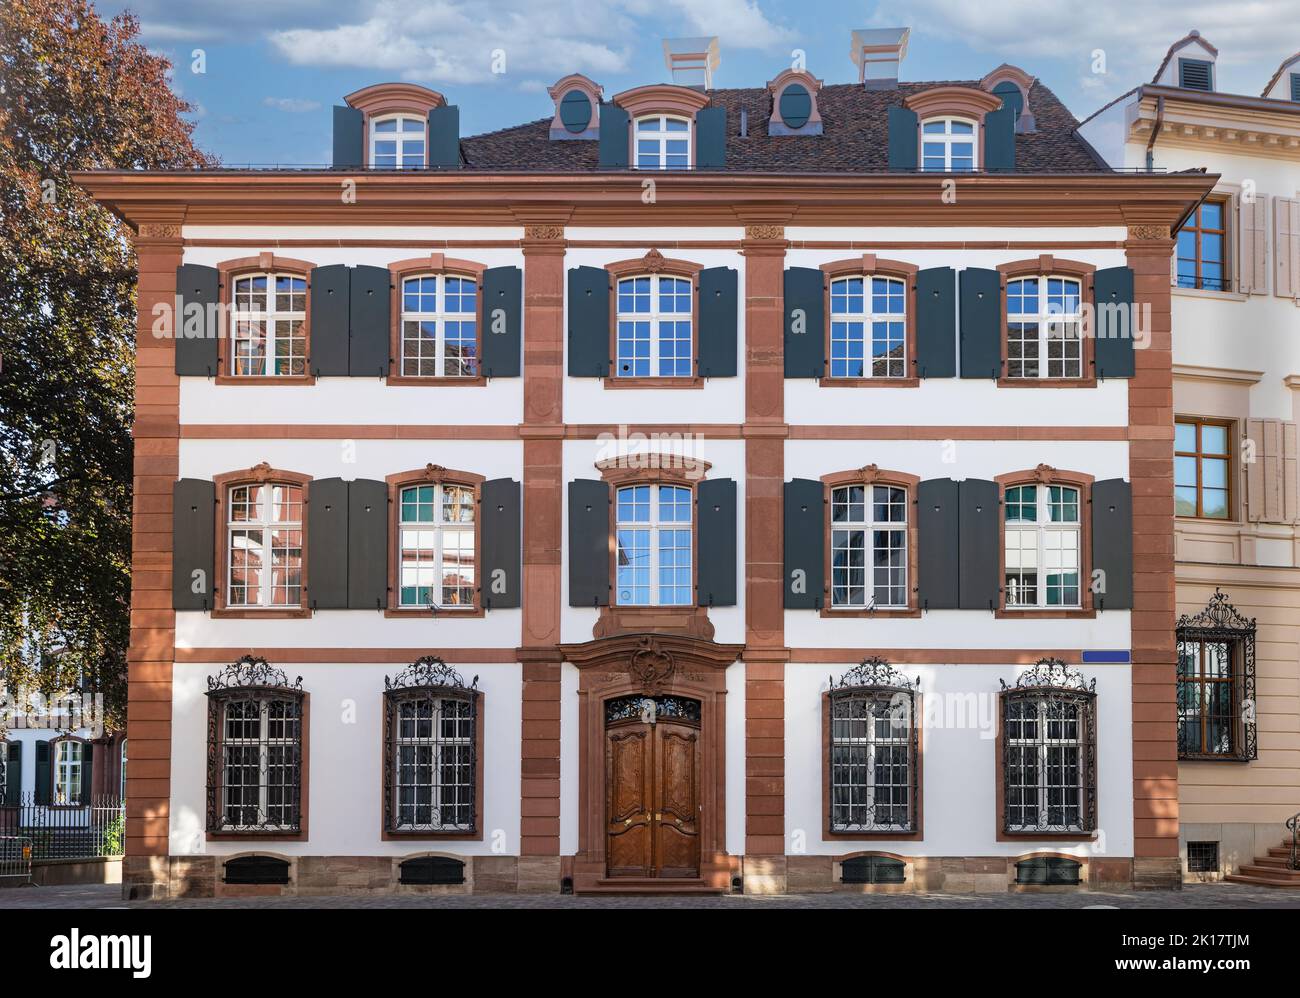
[384,655,480,834]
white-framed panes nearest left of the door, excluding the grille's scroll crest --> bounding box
[389,695,476,832]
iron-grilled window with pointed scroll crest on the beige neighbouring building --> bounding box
[1177,589,1258,761]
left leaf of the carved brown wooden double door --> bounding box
[605,724,654,877]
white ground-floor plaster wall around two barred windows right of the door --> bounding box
[785,663,1134,856]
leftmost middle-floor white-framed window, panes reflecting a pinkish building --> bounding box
[226,482,303,608]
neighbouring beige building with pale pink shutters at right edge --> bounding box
[1079,31,1300,886]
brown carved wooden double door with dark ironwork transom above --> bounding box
[605,697,701,878]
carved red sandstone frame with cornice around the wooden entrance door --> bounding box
[560,634,744,891]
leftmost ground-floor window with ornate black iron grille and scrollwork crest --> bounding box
[207,655,307,834]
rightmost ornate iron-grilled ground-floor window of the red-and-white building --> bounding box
[1001,659,1097,834]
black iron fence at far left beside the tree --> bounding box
[0,794,126,860]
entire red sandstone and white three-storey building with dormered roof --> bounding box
[78,31,1214,897]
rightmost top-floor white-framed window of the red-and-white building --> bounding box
[1006,275,1083,378]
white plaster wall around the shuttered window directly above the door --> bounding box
[560,438,745,645]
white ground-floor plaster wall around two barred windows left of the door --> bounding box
[170,663,523,856]
